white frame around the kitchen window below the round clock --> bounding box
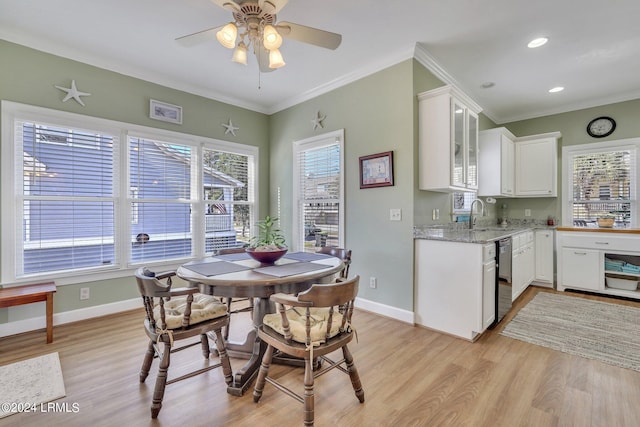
[562,138,640,228]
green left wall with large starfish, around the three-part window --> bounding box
[0,40,269,323]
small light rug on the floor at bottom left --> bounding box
[0,353,66,418]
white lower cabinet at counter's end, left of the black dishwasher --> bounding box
[415,239,496,341]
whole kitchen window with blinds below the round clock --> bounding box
[562,139,640,228]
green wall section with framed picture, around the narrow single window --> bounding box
[270,60,416,310]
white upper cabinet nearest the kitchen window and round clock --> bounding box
[515,132,560,197]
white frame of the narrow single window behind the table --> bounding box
[292,129,345,251]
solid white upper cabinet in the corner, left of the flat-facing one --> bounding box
[478,128,516,197]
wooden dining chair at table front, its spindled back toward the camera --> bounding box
[253,276,364,426]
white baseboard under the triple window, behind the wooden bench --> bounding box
[0,298,141,339]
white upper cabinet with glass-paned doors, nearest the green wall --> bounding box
[418,85,482,192]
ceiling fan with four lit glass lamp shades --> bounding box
[176,0,342,72]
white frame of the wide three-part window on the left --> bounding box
[0,101,259,285]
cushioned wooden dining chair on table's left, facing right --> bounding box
[135,268,232,418]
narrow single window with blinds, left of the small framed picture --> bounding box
[293,130,344,252]
